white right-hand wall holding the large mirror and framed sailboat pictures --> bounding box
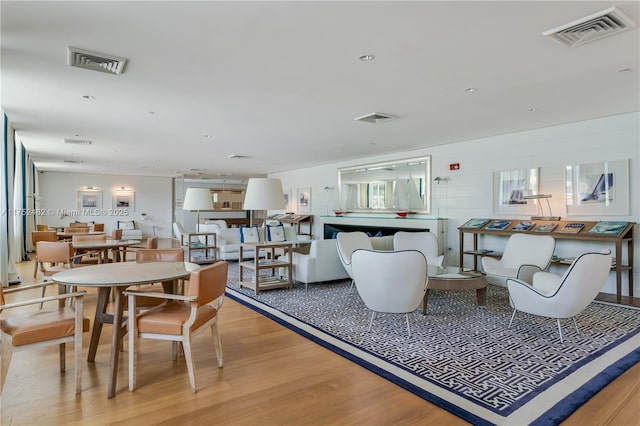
[270,112,640,296]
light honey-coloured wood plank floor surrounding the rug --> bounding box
[0,262,640,426]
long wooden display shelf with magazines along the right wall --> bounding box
[458,219,636,303]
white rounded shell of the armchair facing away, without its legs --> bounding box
[351,249,427,313]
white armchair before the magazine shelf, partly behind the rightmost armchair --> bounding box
[482,234,556,287]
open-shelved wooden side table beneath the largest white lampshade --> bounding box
[238,242,293,294]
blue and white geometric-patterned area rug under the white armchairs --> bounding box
[222,262,640,425]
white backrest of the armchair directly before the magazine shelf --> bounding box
[500,234,556,270]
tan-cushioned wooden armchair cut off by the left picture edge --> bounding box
[0,283,89,394]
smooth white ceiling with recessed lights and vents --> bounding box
[0,0,640,178]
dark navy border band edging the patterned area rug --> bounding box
[226,289,640,425]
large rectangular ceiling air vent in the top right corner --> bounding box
[542,7,636,47]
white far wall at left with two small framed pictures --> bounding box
[37,172,172,238]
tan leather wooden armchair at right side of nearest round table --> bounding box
[124,262,228,392]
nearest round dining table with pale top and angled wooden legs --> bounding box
[51,262,200,398]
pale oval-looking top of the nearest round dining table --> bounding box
[51,262,200,287]
